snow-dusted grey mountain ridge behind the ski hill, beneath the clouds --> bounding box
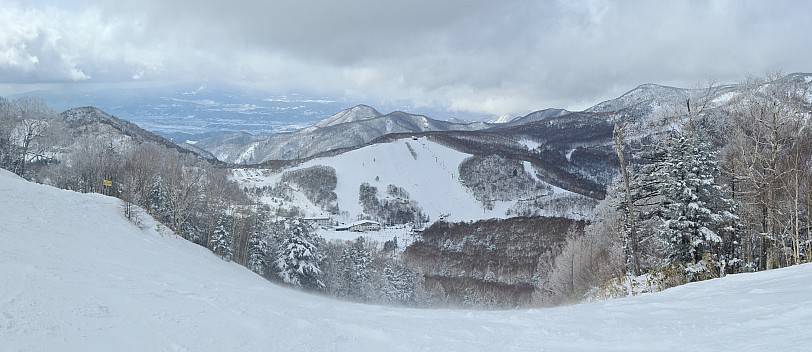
[195,74,809,164]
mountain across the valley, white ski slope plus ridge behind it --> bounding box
[224,74,812,227]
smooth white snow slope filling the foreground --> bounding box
[0,171,812,351]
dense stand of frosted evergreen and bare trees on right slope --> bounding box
[551,75,812,299]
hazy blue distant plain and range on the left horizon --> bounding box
[8,82,490,142]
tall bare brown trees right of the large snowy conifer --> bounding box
[725,75,812,270]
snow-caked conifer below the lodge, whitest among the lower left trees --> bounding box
[274,220,324,290]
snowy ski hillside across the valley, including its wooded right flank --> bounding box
[234,137,592,222]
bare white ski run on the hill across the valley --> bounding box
[233,138,504,222]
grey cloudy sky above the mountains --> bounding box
[0,0,812,115]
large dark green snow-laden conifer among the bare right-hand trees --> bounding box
[632,132,738,281]
